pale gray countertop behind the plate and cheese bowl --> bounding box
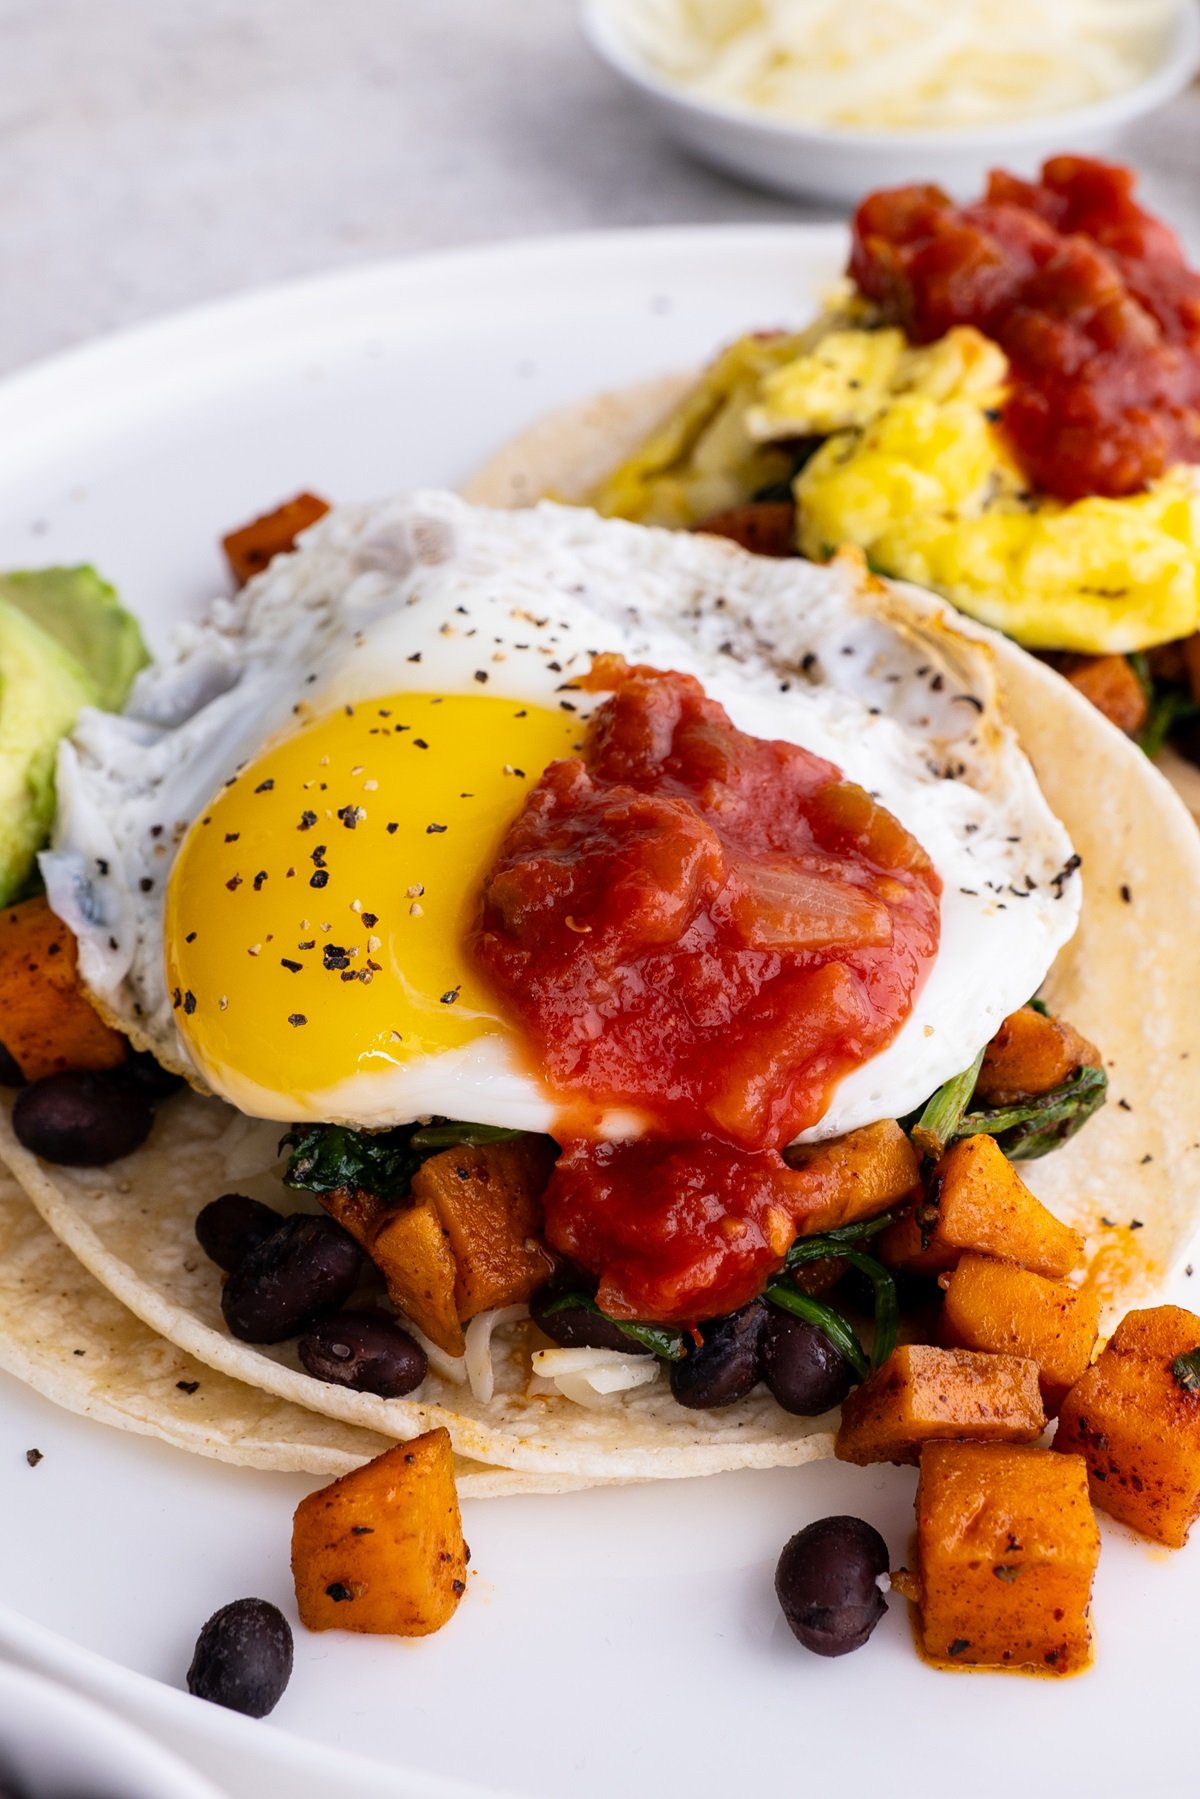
[0,0,1200,379]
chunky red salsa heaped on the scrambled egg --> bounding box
[849,157,1200,500]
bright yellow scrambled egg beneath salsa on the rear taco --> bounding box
[747,326,1200,655]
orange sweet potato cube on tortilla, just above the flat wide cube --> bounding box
[941,1256,1099,1412]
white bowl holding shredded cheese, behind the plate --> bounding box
[583,0,1200,205]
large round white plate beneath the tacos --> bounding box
[0,228,1200,1799]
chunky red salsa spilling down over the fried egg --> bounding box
[473,658,941,1319]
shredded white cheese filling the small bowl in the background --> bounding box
[608,0,1178,130]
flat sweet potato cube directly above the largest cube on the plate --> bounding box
[835,1344,1045,1468]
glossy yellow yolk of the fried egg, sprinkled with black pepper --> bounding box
[166,693,581,1119]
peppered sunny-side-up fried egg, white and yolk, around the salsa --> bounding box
[43,493,1079,1137]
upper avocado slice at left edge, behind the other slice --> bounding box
[0,565,149,712]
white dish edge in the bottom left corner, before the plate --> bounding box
[0,1662,221,1799]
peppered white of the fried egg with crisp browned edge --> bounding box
[43,493,1081,1139]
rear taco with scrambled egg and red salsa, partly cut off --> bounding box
[471,157,1200,811]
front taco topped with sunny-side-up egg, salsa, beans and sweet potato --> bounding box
[0,489,1200,1488]
